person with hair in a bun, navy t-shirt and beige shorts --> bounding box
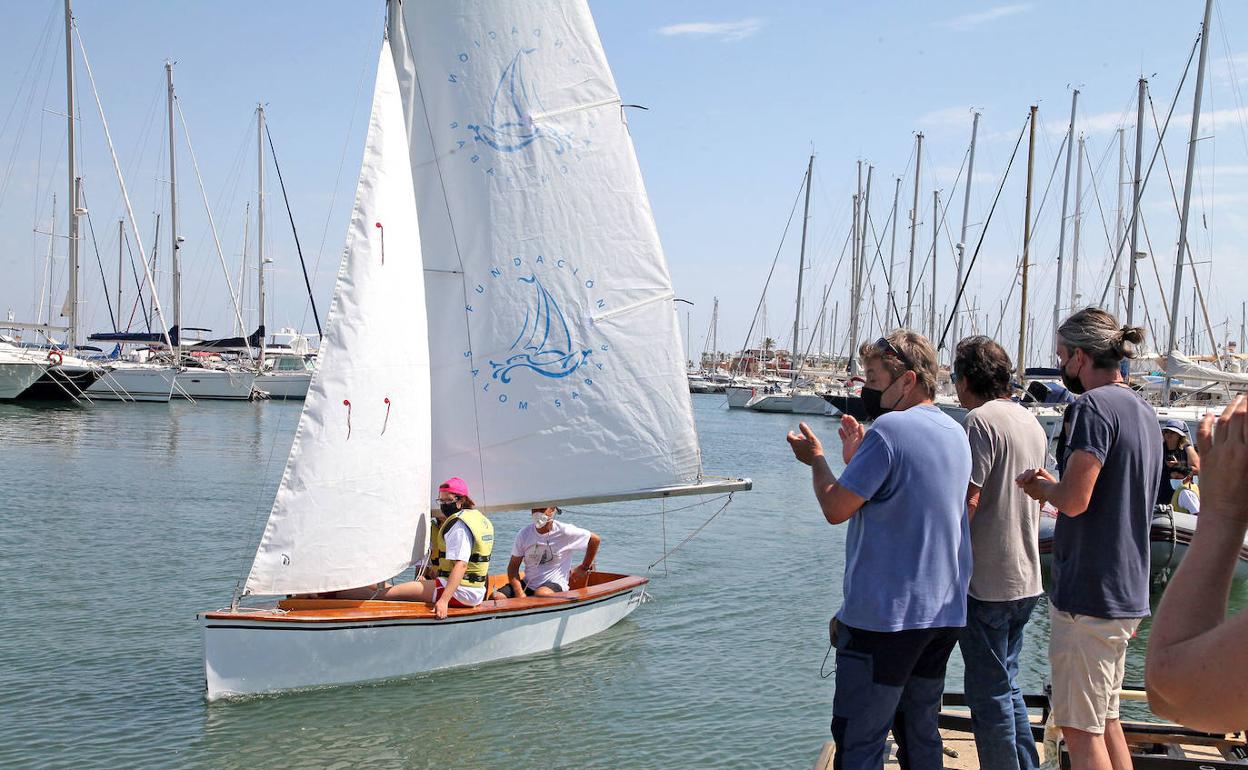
[1017,307,1162,770]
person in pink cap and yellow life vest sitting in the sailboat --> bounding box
[332,477,494,618]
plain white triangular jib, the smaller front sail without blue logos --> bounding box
[246,38,432,595]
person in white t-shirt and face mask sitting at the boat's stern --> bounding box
[494,507,603,599]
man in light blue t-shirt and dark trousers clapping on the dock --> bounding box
[789,329,971,770]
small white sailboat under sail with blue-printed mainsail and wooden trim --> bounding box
[200,0,751,699]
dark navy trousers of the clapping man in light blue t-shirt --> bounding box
[832,624,958,770]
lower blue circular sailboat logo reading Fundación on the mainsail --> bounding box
[464,255,610,412]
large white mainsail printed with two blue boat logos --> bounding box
[389,0,723,509]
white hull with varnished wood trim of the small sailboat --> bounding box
[200,574,646,700]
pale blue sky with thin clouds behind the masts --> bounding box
[0,0,1248,363]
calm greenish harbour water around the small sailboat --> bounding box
[0,396,1228,768]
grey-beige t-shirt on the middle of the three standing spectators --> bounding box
[966,399,1047,602]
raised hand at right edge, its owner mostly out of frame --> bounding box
[1196,396,1248,524]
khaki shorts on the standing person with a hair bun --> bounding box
[1048,605,1141,735]
